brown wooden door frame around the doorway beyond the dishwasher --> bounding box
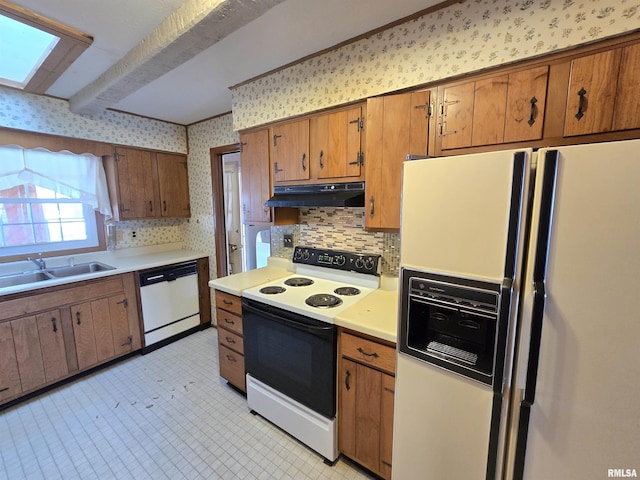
[209,143,241,278]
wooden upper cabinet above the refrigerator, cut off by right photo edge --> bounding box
[564,44,640,137]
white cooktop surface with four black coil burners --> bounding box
[242,265,380,323]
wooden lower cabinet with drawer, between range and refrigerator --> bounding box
[338,330,396,479]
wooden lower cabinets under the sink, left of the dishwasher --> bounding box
[0,273,141,404]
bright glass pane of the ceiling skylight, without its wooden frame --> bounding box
[0,15,60,89]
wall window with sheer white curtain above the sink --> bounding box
[0,145,111,257]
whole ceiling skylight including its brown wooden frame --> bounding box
[0,2,93,94]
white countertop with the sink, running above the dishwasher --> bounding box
[0,243,208,296]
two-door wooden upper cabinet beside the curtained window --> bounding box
[104,147,190,221]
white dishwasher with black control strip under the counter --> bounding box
[139,261,200,353]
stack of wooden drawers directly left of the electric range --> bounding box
[215,290,247,392]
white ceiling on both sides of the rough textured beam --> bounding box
[14,0,441,125]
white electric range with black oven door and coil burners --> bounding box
[242,247,380,463]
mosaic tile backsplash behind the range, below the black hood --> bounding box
[271,207,400,276]
